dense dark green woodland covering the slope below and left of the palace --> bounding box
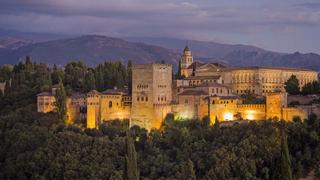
[0,57,320,179]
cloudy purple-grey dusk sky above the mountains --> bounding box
[0,0,320,53]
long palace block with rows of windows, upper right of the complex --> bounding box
[221,67,318,95]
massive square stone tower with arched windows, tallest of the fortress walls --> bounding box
[130,64,172,130]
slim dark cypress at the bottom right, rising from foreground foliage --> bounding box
[278,122,292,180]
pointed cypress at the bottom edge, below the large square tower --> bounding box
[125,132,139,180]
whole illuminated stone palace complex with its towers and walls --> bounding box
[37,47,318,130]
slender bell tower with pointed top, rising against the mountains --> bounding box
[180,45,193,77]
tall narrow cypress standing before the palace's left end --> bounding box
[55,80,67,123]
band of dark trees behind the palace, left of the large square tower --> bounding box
[0,57,132,96]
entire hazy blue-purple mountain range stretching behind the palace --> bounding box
[0,31,320,70]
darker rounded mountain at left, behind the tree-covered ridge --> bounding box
[0,35,179,65]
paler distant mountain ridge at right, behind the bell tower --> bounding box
[125,37,320,70]
